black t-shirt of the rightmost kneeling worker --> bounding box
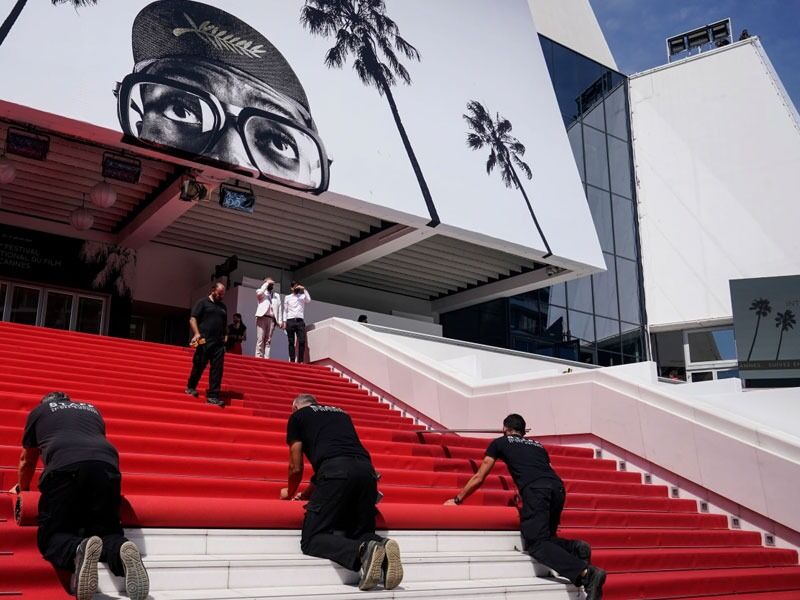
[486,435,564,491]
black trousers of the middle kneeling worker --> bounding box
[300,457,383,571]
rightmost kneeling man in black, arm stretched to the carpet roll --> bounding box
[445,414,606,600]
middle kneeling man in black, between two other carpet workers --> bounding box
[281,394,403,590]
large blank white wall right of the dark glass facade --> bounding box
[630,38,800,328]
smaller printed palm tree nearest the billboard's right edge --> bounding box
[464,100,553,258]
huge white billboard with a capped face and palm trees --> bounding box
[0,0,604,270]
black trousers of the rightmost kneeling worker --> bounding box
[520,485,588,585]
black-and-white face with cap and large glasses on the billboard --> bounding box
[116,0,329,193]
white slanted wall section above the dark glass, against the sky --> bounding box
[528,0,617,70]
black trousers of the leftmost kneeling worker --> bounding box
[37,461,128,576]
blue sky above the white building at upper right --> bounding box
[590,0,800,107]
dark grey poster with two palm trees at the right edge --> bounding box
[730,275,800,381]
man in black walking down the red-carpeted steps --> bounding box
[186,282,228,406]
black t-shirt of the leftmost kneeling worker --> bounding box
[22,402,119,473]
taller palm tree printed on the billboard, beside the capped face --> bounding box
[300,0,440,227]
